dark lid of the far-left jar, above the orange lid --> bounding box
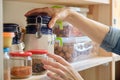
[3,23,19,32]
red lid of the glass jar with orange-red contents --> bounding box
[10,51,32,57]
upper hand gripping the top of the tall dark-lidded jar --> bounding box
[25,7,70,28]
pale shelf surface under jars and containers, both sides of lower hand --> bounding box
[12,57,112,80]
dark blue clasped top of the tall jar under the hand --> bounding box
[26,13,52,37]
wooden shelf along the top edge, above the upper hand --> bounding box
[6,0,110,6]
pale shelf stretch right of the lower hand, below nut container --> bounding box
[71,57,113,71]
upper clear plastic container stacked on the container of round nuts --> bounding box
[53,21,83,37]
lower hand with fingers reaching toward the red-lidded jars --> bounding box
[42,54,83,80]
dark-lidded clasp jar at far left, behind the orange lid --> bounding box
[3,23,24,52]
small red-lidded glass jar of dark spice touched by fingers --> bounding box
[29,50,48,75]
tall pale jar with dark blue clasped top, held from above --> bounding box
[24,13,54,51]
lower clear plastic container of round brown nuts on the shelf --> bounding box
[54,37,96,62]
